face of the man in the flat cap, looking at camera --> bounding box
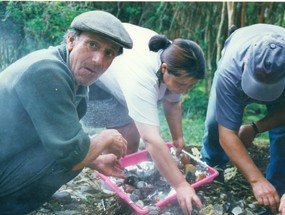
[67,32,120,86]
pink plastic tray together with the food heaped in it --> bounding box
[97,144,218,215]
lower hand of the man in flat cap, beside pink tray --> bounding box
[88,154,126,178]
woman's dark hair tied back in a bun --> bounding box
[148,35,205,79]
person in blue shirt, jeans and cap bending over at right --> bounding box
[202,24,285,211]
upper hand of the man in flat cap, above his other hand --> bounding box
[99,129,128,158]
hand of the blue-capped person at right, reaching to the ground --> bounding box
[251,178,280,213]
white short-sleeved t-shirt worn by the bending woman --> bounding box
[95,23,180,126]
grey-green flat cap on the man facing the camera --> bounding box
[70,10,133,49]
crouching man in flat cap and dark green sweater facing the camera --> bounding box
[0,11,132,215]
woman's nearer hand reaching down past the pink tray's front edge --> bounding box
[175,181,203,215]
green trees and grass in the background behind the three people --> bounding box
[0,1,276,145]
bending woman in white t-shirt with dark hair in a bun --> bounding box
[83,24,205,214]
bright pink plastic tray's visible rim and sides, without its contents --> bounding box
[97,144,219,215]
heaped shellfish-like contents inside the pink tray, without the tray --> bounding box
[106,148,210,207]
